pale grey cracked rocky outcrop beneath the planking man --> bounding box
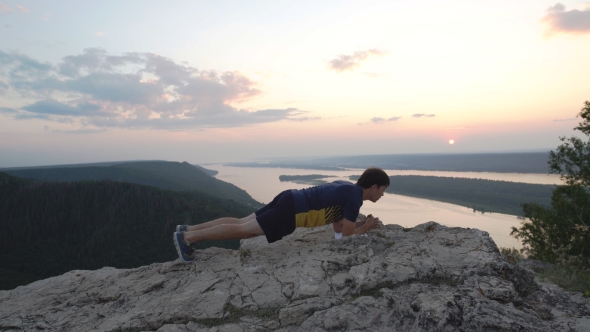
[0,222,590,332]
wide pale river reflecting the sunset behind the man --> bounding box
[208,164,561,248]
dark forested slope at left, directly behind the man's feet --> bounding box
[0,173,254,289]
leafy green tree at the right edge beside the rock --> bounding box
[511,101,590,271]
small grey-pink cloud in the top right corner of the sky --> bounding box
[541,3,590,34]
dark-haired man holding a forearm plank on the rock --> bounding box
[174,167,389,263]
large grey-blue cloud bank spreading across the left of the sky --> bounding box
[0,48,316,130]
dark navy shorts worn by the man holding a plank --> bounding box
[255,190,295,243]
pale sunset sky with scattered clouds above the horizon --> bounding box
[0,0,590,167]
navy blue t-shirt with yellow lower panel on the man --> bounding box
[291,181,363,227]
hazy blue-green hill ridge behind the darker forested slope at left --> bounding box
[0,161,261,207]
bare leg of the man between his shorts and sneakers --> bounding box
[184,218,264,243]
